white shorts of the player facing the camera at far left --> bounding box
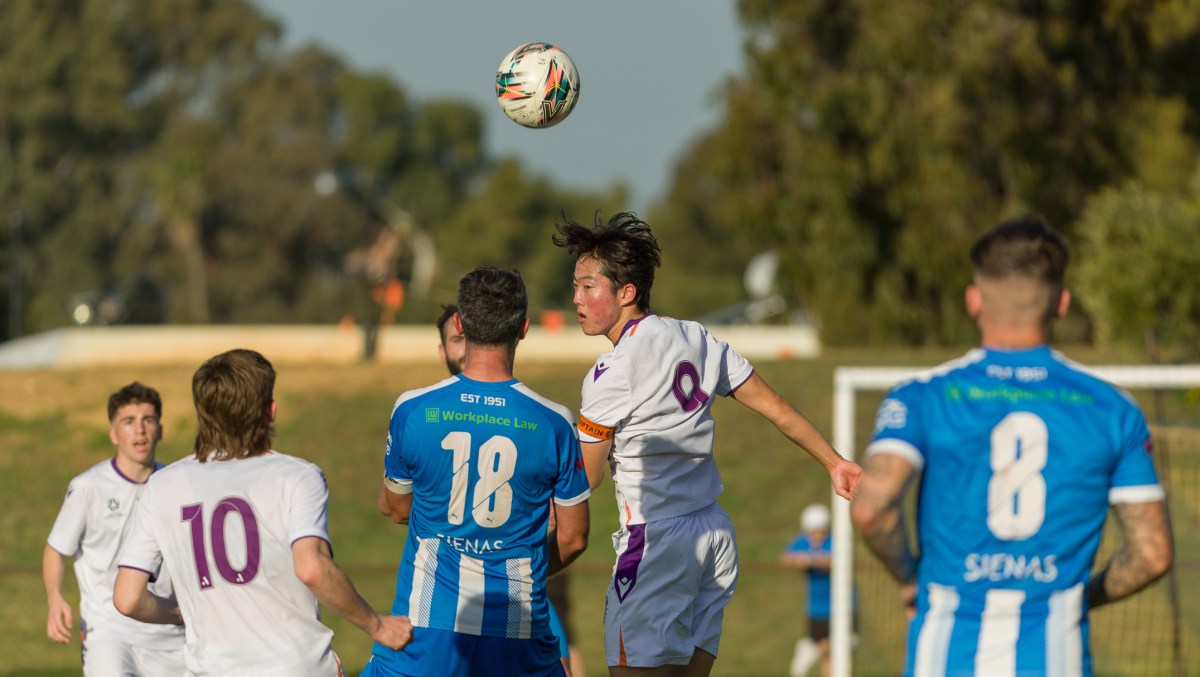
[79,621,187,677]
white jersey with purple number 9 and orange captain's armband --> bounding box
[580,314,754,525]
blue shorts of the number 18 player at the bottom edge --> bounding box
[359,628,566,677]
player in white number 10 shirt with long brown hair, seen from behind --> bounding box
[113,349,412,677]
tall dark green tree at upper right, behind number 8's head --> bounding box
[696,0,1200,343]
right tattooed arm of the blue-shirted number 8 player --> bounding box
[1087,501,1175,609]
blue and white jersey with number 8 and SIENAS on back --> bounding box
[866,347,1164,675]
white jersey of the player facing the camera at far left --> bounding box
[47,459,184,646]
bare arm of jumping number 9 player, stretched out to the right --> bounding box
[732,372,863,501]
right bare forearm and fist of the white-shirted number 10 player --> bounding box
[292,537,413,651]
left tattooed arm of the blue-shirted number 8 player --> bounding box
[850,454,917,595]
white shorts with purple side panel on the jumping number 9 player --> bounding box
[604,503,738,667]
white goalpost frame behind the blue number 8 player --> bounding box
[829,365,1200,677]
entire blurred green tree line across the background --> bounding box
[0,0,1200,353]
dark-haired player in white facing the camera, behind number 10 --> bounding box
[42,382,184,677]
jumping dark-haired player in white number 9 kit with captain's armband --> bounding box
[554,212,863,676]
